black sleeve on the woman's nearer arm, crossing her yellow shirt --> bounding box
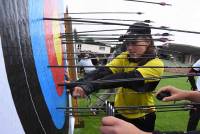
[80,70,158,94]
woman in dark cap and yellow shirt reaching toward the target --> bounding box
[73,23,164,132]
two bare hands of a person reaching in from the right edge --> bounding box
[100,86,200,134]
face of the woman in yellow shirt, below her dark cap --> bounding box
[127,37,150,58]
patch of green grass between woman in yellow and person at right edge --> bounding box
[155,73,190,131]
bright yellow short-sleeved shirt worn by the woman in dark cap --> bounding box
[106,52,164,118]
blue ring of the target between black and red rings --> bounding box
[29,0,67,129]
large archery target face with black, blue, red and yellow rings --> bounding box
[0,0,68,134]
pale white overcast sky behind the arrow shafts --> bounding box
[66,0,200,47]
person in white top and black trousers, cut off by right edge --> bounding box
[187,59,200,131]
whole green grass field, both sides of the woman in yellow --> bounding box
[75,73,200,134]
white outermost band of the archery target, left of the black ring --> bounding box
[0,37,24,134]
